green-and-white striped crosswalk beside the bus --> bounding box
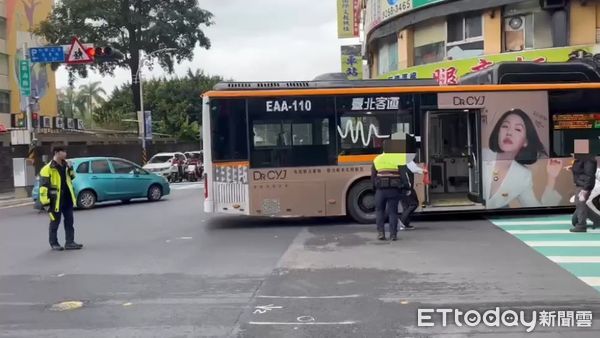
[490,215,600,291]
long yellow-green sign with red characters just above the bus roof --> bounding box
[380,46,598,85]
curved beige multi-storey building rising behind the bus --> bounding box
[362,0,600,85]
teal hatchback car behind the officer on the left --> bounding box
[32,157,171,209]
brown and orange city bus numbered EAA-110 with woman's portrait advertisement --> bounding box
[202,67,600,223]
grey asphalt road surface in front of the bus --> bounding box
[0,184,600,337]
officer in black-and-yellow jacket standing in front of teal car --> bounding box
[40,146,83,251]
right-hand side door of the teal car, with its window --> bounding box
[110,158,151,198]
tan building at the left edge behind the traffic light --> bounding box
[0,0,58,131]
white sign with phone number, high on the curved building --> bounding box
[365,0,448,33]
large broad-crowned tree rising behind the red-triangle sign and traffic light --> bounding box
[35,0,213,111]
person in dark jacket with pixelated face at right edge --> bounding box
[569,140,598,232]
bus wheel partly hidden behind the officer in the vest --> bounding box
[346,180,375,224]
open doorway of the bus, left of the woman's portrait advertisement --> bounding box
[422,110,482,208]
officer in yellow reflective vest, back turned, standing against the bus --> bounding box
[371,139,414,241]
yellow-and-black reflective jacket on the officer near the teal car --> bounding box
[40,160,77,212]
